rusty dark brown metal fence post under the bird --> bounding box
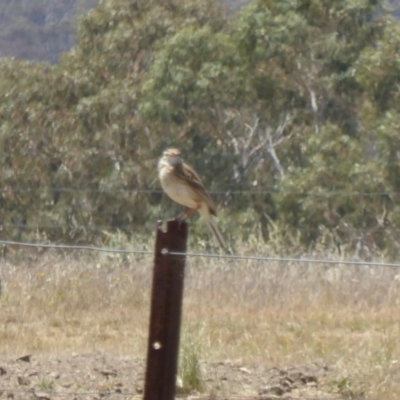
[144,220,188,400]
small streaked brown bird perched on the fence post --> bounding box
[158,149,227,249]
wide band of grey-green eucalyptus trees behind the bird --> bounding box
[0,0,400,257]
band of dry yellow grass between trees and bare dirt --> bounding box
[0,239,400,399]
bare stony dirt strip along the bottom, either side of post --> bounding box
[0,353,337,400]
